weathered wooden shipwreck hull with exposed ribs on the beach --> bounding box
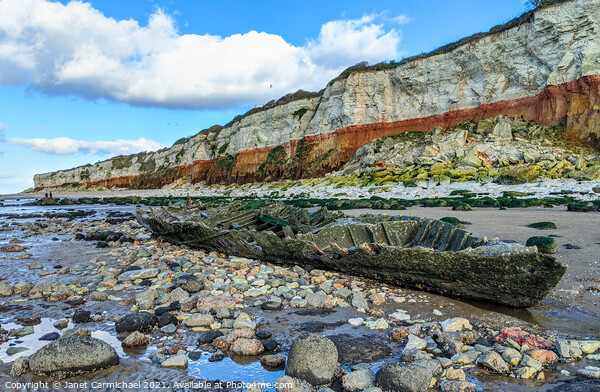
[137,203,567,307]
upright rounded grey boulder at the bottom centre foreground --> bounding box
[285,334,338,386]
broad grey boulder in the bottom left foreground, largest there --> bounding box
[29,336,119,379]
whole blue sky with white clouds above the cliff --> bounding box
[0,0,526,194]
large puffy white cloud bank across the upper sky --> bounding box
[0,0,402,109]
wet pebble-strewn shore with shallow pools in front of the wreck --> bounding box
[0,201,600,392]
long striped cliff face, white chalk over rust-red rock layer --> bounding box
[34,0,600,188]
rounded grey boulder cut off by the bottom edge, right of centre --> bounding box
[375,360,433,392]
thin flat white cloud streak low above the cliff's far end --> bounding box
[6,137,165,155]
